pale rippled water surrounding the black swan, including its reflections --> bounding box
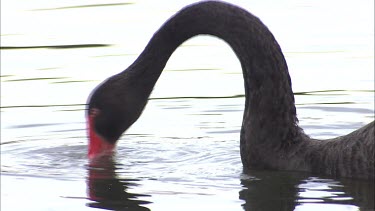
[1,0,374,210]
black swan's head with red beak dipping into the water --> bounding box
[86,74,148,159]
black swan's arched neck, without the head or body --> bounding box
[125,2,298,147]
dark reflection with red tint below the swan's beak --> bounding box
[87,156,151,211]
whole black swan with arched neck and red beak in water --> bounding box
[87,1,375,179]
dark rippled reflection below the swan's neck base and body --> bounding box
[239,170,374,211]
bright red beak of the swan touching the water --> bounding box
[87,114,115,159]
